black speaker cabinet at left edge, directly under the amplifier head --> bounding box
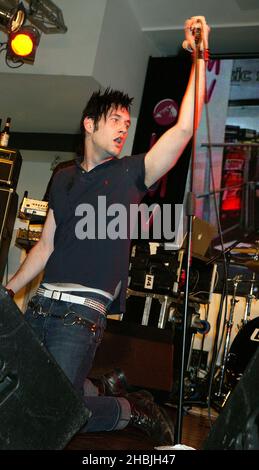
[0,187,18,282]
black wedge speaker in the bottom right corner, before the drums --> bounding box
[203,346,259,450]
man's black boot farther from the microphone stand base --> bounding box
[90,368,128,397]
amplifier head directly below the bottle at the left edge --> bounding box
[0,147,22,189]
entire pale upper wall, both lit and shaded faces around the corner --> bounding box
[0,0,160,106]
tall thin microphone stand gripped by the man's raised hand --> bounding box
[174,36,203,444]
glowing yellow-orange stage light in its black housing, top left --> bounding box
[7,26,40,64]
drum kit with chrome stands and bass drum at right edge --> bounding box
[213,241,259,408]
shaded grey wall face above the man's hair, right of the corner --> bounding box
[93,0,160,116]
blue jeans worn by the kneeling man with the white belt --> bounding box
[25,292,121,432]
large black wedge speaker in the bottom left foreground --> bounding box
[0,286,89,450]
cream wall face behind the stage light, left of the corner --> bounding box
[0,0,107,76]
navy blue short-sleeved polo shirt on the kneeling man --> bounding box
[43,154,147,312]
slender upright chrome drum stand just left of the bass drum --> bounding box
[215,275,242,406]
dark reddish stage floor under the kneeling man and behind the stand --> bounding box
[66,406,216,450]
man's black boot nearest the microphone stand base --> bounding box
[126,394,174,445]
